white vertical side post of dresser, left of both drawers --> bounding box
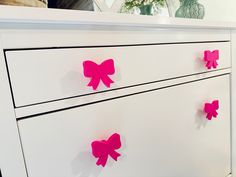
[0,37,26,177]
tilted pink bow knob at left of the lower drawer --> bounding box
[91,133,121,167]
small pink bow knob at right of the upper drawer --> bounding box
[204,50,219,69]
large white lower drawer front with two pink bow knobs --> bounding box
[18,75,230,177]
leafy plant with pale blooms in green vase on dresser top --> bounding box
[124,0,165,15]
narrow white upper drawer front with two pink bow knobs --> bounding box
[6,42,230,107]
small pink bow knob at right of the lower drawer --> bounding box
[204,100,219,120]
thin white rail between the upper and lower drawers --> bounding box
[15,69,231,118]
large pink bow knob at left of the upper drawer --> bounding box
[83,59,115,90]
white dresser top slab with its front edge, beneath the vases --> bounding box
[0,5,236,29]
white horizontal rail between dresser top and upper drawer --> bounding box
[1,28,230,49]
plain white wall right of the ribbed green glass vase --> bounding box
[199,0,236,21]
